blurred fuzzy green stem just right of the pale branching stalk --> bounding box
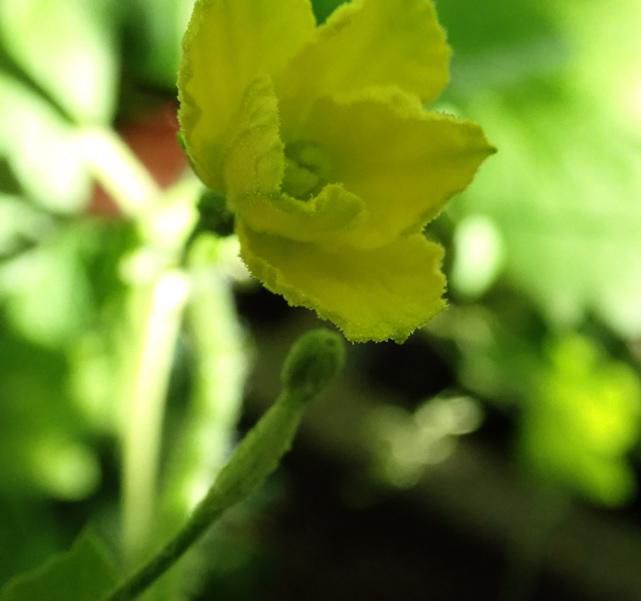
[148,233,247,599]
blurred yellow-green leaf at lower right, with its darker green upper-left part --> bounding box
[431,308,641,505]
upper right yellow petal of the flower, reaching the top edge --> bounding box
[277,0,451,140]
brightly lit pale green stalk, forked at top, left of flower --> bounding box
[78,127,197,562]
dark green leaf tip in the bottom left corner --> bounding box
[0,532,117,601]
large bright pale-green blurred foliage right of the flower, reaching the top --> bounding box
[441,0,641,336]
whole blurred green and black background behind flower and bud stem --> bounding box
[0,0,641,601]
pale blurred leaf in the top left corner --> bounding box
[0,0,116,123]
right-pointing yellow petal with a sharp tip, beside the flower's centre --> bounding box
[302,90,494,247]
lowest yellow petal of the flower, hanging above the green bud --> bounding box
[237,223,445,342]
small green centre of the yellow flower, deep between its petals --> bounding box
[282,142,329,200]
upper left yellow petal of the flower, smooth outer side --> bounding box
[178,0,315,192]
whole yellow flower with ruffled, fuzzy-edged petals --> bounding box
[179,0,493,341]
